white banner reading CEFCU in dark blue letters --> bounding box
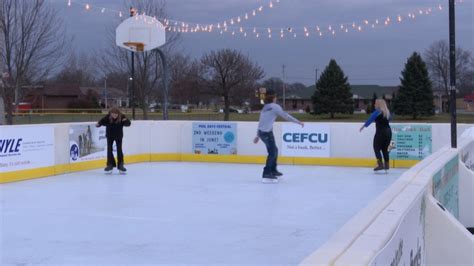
[281,123,331,158]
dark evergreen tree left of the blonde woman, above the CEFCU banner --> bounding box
[312,59,354,118]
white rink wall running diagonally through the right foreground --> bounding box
[302,127,474,265]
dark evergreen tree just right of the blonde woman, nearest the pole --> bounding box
[393,52,434,119]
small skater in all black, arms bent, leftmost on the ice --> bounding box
[96,108,131,172]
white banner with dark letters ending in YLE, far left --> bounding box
[0,126,54,172]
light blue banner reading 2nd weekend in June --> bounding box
[193,122,237,154]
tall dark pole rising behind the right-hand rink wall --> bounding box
[449,0,457,148]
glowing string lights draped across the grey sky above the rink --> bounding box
[67,0,464,39]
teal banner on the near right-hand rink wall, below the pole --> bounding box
[433,155,459,218]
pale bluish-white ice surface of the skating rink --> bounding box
[0,163,404,265]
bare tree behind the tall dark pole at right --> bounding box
[424,40,473,99]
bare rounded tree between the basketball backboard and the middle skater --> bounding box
[201,49,264,121]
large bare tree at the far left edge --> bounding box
[0,0,67,124]
